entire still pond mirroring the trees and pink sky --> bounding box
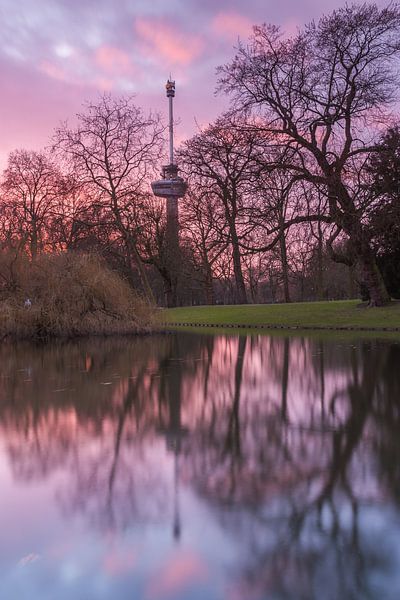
[0,333,400,600]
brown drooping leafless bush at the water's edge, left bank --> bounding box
[0,253,154,339]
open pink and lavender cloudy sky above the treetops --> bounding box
[0,0,387,167]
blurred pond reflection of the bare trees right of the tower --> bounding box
[188,340,400,598]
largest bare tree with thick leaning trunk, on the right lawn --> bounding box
[219,3,400,305]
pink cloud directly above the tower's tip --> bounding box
[135,18,203,66]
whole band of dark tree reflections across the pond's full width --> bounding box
[0,335,400,598]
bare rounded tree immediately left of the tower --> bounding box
[55,95,164,298]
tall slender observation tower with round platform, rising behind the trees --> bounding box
[151,80,187,306]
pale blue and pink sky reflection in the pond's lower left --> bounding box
[0,452,240,600]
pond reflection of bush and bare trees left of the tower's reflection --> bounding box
[0,336,206,528]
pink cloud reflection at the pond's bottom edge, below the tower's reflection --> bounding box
[146,552,207,600]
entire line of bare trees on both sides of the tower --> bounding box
[0,4,400,306]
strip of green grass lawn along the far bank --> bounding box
[158,300,400,329]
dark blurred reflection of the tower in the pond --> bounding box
[156,359,188,540]
